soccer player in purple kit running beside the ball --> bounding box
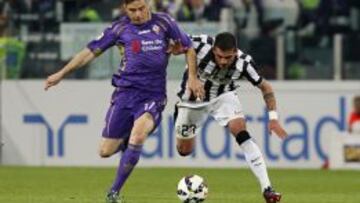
[45,0,204,203]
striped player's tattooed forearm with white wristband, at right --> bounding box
[258,80,287,139]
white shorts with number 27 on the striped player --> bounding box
[175,91,244,139]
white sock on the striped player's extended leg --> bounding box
[240,139,271,192]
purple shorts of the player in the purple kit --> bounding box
[102,88,166,139]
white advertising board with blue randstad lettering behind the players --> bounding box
[1,80,359,168]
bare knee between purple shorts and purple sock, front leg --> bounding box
[129,112,155,145]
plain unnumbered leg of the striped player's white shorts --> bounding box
[210,92,245,126]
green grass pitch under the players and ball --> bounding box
[0,166,360,203]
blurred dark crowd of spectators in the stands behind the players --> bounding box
[0,0,360,79]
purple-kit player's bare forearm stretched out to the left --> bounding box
[45,48,96,90]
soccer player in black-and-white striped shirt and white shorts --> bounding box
[171,32,287,203]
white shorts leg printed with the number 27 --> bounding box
[174,105,207,140]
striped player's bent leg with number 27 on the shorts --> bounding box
[174,104,205,156]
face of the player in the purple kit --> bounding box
[125,0,150,25]
